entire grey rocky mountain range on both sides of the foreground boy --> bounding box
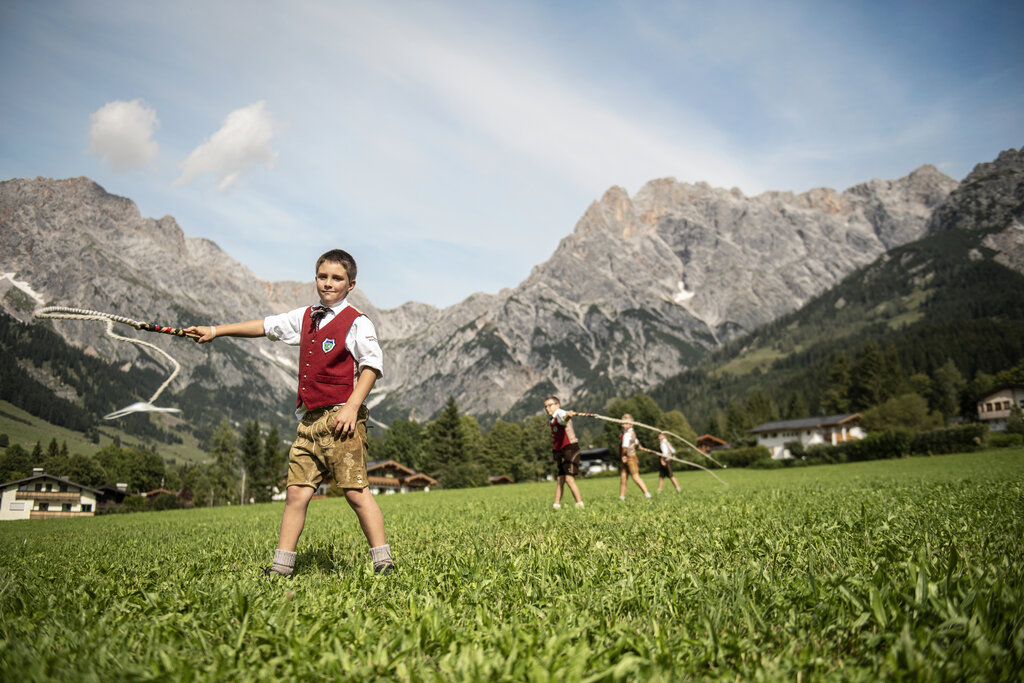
[0,151,1020,432]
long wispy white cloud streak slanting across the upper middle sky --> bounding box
[311,5,753,194]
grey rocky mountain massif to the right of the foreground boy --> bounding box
[379,166,957,417]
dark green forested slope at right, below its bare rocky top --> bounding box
[651,230,1024,436]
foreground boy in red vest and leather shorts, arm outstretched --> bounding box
[186,249,394,579]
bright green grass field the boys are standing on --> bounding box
[0,449,1024,681]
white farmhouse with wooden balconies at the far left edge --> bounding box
[0,468,101,520]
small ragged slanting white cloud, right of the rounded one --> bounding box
[174,101,278,191]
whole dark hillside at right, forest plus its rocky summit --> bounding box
[651,150,1024,438]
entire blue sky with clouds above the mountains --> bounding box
[0,0,1024,308]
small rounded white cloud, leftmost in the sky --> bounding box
[89,99,160,171]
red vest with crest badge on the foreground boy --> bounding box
[295,306,362,411]
